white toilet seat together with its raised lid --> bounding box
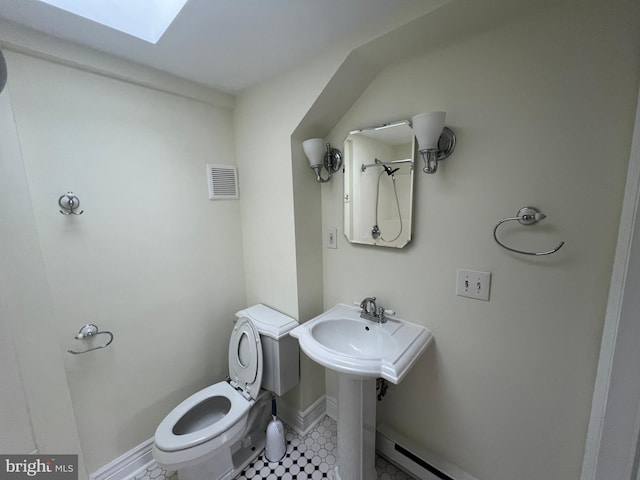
[155,318,262,453]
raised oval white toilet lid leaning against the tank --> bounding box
[229,318,262,400]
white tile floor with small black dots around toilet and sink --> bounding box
[134,416,413,480]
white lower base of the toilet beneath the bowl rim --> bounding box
[172,390,271,480]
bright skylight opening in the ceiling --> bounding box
[40,0,187,43]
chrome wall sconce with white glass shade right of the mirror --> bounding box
[411,112,456,173]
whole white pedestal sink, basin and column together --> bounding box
[290,304,433,480]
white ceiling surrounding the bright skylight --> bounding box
[0,0,443,94]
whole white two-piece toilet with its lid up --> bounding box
[152,305,299,480]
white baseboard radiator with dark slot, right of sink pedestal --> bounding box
[376,425,477,480]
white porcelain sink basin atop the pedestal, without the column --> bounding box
[290,304,433,384]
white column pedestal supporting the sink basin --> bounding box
[335,374,376,480]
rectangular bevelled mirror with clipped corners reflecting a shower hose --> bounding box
[344,120,415,248]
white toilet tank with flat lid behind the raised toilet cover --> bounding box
[236,304,300,395]
